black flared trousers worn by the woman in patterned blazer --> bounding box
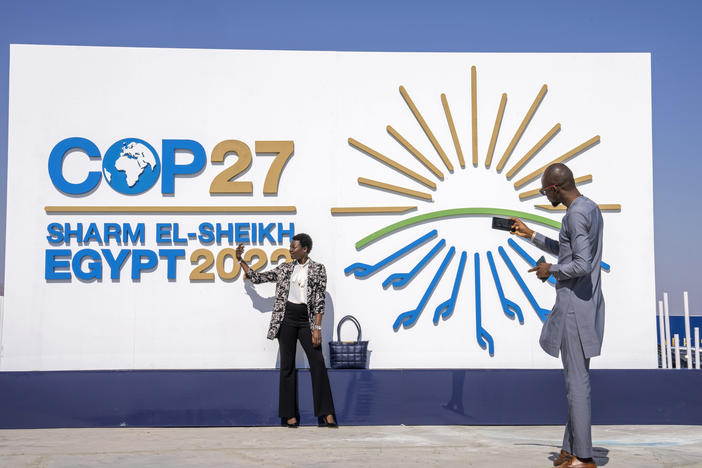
[278,302,335,420]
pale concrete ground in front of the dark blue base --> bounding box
[0,426,702,468]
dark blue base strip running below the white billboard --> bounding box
[0,369,702,429]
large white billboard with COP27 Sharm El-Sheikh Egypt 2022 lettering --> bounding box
[0,45,656,370]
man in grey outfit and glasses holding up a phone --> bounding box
[512,164,604,468]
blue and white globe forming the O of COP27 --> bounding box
[102,138,161,195]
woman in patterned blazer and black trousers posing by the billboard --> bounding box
[236,234,338,427]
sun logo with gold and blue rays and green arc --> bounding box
[331,66,621,356]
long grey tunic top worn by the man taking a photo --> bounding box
[534,196,604,358]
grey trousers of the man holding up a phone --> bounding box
[561,312,592,458]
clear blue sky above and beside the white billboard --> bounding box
[0,0,702,315]
